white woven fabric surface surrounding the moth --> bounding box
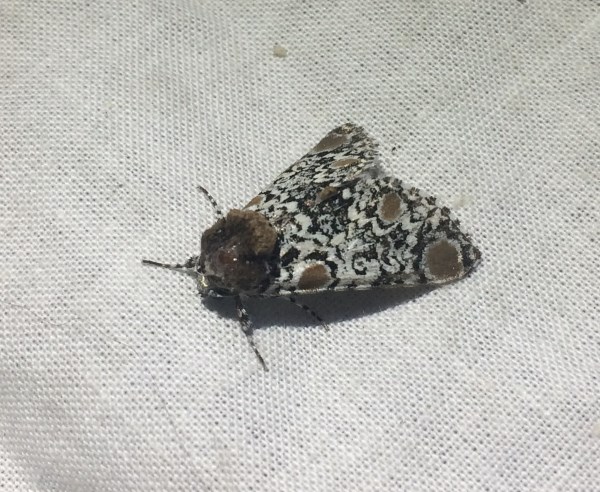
[0,0,600,491]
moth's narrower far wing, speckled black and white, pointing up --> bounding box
[244,123,378,227]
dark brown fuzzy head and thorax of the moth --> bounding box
[197,209,278,297]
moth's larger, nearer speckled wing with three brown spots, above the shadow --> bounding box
[264,175,480,295]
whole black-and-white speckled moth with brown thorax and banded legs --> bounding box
[143,123,481,368]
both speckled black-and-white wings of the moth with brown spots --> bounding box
[245,124,480,295]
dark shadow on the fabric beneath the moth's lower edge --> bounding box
[204,286,435,329]
